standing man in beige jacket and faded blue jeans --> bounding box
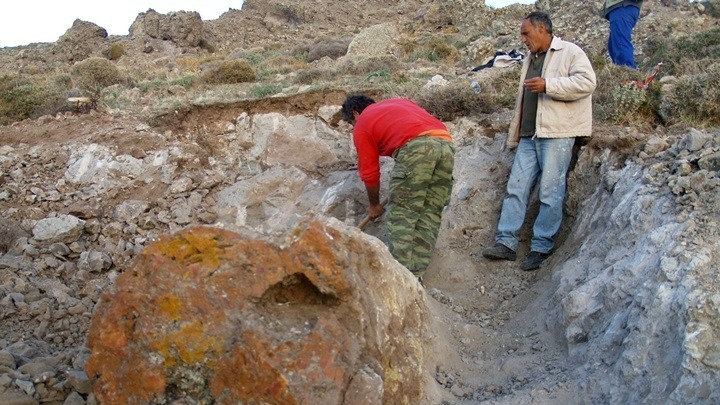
[482,11,596,270]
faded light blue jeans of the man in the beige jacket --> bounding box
[495,137,575,253]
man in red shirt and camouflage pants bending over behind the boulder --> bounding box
[342,95,455,278]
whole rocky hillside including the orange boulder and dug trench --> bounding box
[0,0,720,404]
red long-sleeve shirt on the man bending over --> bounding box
[353,98,452,187]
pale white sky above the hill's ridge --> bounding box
[0,0,535,47]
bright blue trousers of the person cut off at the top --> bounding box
[608,5,640,69]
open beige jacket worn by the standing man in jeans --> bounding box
[507,37,597,148]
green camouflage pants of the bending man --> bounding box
[386,136,455,277]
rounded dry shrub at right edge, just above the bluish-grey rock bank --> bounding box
[661,63,720,126]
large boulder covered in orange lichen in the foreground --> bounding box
[86,219,433,404]
